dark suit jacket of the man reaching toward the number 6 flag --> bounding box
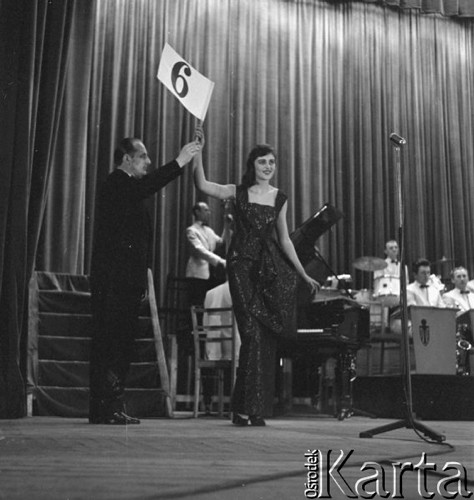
[91,161,182,289]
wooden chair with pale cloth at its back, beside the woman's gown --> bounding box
[191,306,237,418]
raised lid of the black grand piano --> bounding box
[290,203,344,267]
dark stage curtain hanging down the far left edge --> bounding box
[0,0,73,418]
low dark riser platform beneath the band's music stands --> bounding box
[353,375,474,420]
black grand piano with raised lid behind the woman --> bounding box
[282,204,369,420]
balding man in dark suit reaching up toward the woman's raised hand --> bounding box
[89,138,200,425]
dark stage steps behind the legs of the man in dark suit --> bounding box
[30,273,165,418]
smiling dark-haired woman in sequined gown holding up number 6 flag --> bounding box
[194,129,319,425]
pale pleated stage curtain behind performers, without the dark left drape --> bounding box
[37,0,474,297]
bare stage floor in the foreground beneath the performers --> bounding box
[0,412,474,500]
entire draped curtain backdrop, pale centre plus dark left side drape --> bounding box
[0,0,474,418]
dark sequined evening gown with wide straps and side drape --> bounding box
[227,186,296,417]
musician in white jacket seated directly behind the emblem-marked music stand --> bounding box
[407,259,446,308]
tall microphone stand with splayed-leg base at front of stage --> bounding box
[359,134,446,443]
